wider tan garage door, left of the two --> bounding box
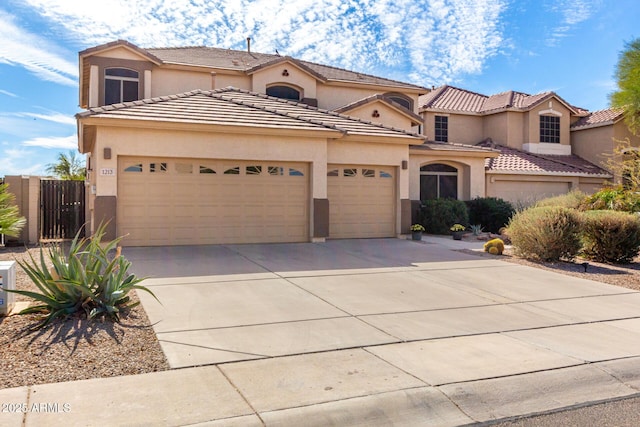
[117,157,309,246]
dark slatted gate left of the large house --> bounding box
[40,180,85,239]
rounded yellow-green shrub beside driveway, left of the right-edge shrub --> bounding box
[506,206,581,261]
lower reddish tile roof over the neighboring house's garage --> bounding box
[478,141,611,178]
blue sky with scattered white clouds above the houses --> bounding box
[0,0,640,177]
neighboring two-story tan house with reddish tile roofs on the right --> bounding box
[419,86,611,205]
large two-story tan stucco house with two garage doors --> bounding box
[77,40,497,245]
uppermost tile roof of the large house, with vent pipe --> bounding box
[143,46,428,93]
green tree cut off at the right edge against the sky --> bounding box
[609,38,640,135]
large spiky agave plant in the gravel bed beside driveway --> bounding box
[7,224,157,326]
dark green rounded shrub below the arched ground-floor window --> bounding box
[419,199,469,234]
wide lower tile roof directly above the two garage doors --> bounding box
[77,87,424,141]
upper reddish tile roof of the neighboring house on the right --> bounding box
[419,85,585,115]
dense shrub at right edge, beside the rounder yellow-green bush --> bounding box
[582,211,640,264]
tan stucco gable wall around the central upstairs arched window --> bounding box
[251,62,317,98]
